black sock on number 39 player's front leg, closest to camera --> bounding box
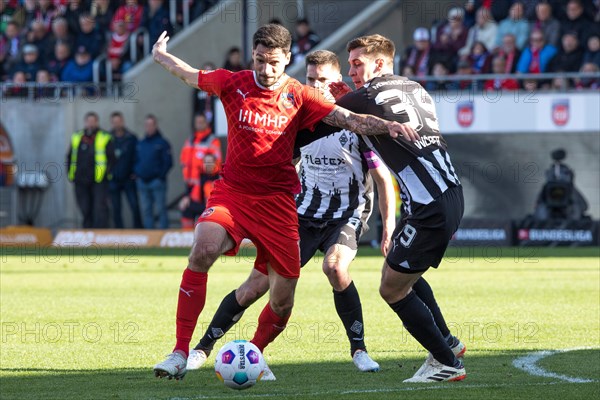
[389,291,460,367]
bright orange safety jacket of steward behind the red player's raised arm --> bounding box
[179,129,222,203]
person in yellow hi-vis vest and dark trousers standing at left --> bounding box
[67,112,115,229]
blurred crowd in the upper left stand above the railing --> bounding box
[0,0,218,84]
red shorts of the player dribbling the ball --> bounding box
[198,180,300,279]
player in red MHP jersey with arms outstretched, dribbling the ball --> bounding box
[152,24,418,379]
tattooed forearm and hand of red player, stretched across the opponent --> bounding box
[323,106,419,141]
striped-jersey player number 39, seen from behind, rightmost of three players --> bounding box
[326,35,466,382]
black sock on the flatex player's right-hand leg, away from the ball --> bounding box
[333,282,367,355]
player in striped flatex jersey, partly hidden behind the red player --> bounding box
[187,50,395,380]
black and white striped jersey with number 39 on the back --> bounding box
[337,75,460,215]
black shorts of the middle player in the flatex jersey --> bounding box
[298,215,363,267]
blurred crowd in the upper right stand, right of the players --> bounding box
[401,0,600,90]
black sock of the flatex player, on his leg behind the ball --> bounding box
[194,290,248,353]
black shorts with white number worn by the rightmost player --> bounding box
[386,186,464,273]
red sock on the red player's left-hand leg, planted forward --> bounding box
[173,268,208,356]
